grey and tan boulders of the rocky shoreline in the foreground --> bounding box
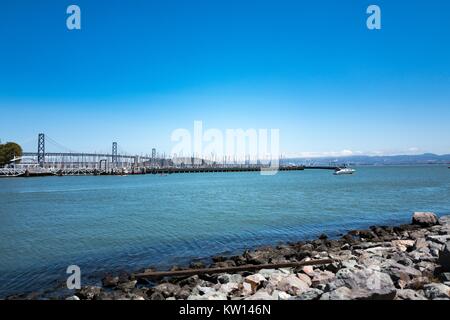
[10,212,450,300]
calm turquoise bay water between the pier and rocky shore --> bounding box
[0,166,450,297]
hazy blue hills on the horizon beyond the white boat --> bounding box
[281,153,450,166]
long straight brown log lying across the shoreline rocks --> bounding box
[133,259,334,278]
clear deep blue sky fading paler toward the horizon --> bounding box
[0,0,450,155]
